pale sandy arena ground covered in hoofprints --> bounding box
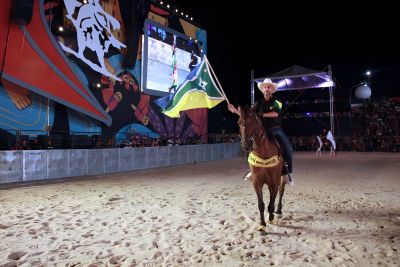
[0,152,400,267]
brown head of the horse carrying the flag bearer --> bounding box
[238,107,263,152]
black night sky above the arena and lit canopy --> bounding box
[167,0,400,107]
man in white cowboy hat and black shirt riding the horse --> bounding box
[228,78,294,185]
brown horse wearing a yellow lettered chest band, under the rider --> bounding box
[238,108,285,232]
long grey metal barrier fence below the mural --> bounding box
[0,143,240,184]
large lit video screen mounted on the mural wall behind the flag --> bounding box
[141,20,201,96]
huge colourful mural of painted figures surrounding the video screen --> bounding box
[0,0,208,149]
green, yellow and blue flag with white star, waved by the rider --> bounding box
[155,60,225,118]
